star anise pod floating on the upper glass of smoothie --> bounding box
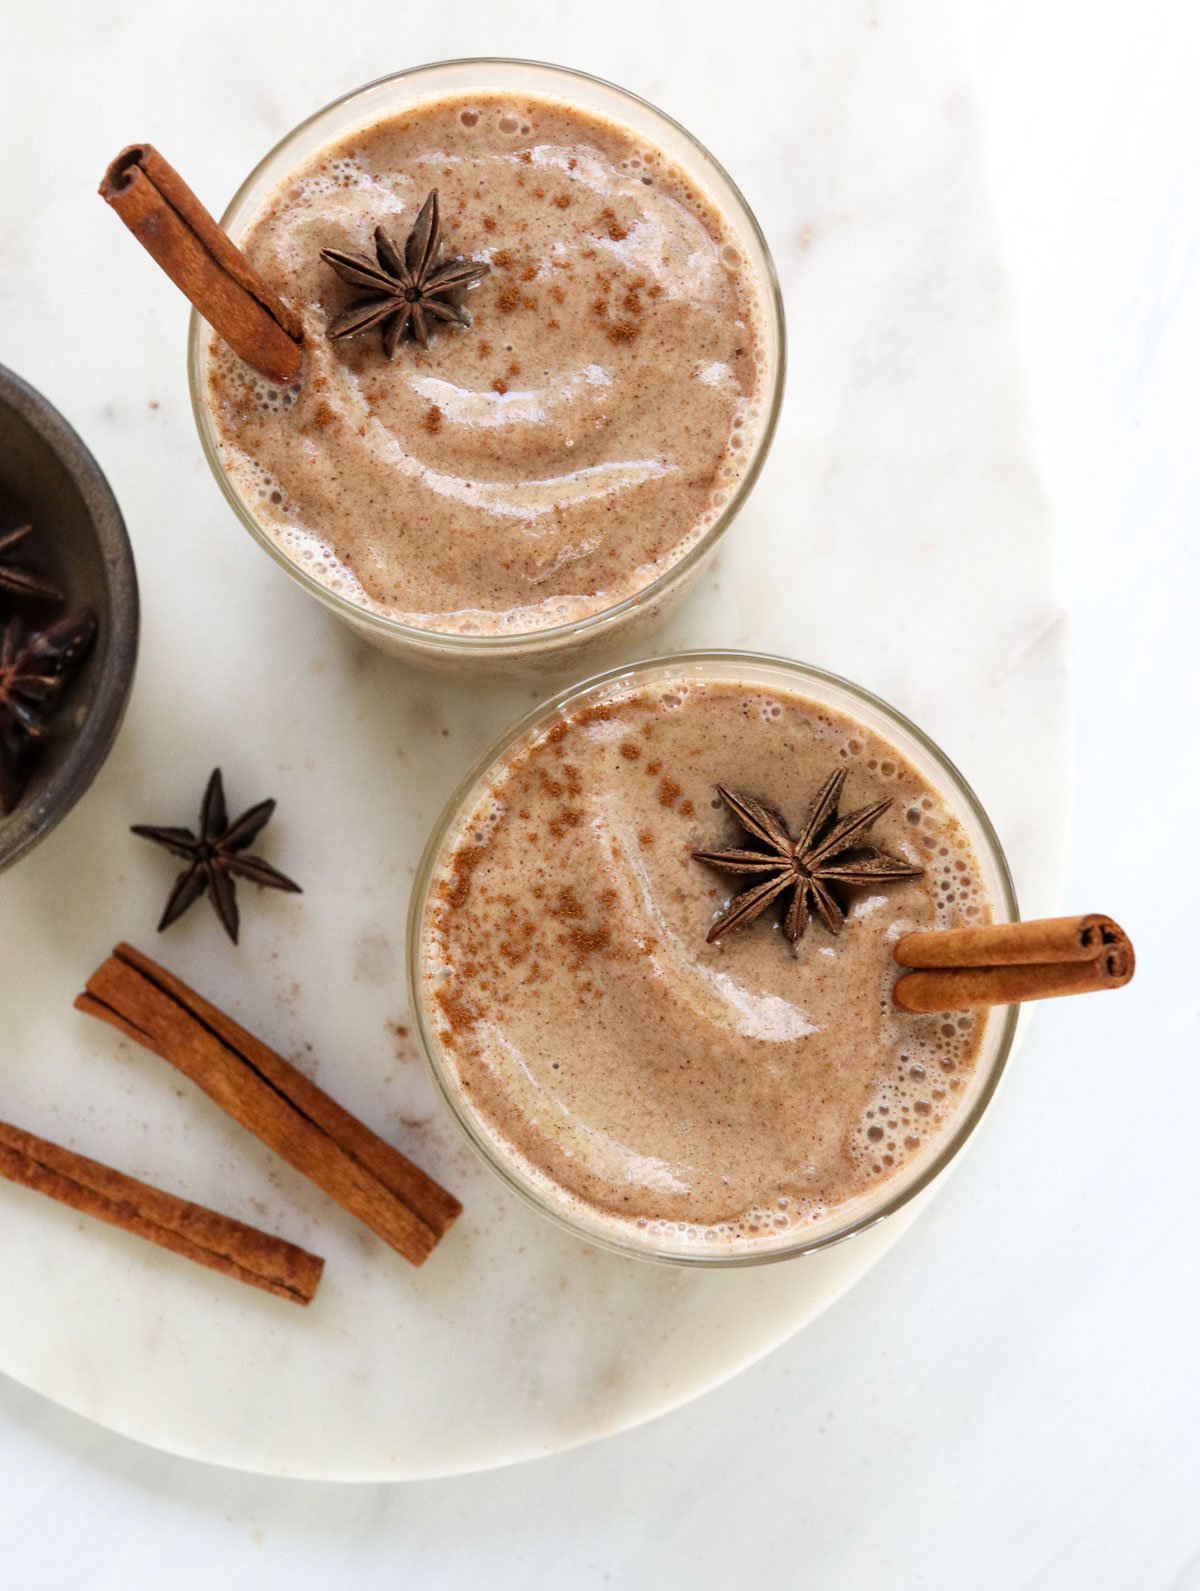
[321,188,492,358]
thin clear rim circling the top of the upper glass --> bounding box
[188,56,788,657]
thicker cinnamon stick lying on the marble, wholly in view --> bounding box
[75,945,462,1265]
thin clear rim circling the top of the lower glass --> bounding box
[406,648,1020,1268]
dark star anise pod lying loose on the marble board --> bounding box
[134,768,302,943]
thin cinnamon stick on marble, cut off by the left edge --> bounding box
[0,1122,325,1305]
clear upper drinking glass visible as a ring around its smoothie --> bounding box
[188,59,785,668]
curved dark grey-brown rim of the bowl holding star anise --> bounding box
[0,364,140,870]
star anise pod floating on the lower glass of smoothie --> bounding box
[692,768,925,945]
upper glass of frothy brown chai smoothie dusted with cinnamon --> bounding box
[189,60,785,665]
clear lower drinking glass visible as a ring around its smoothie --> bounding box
[407,651,1017,1266]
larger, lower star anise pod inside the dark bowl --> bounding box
[0,608,95,813]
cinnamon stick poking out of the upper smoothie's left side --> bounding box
[100,143,304,387]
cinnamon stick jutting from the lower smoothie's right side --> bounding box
[893,913,1135,1012]
